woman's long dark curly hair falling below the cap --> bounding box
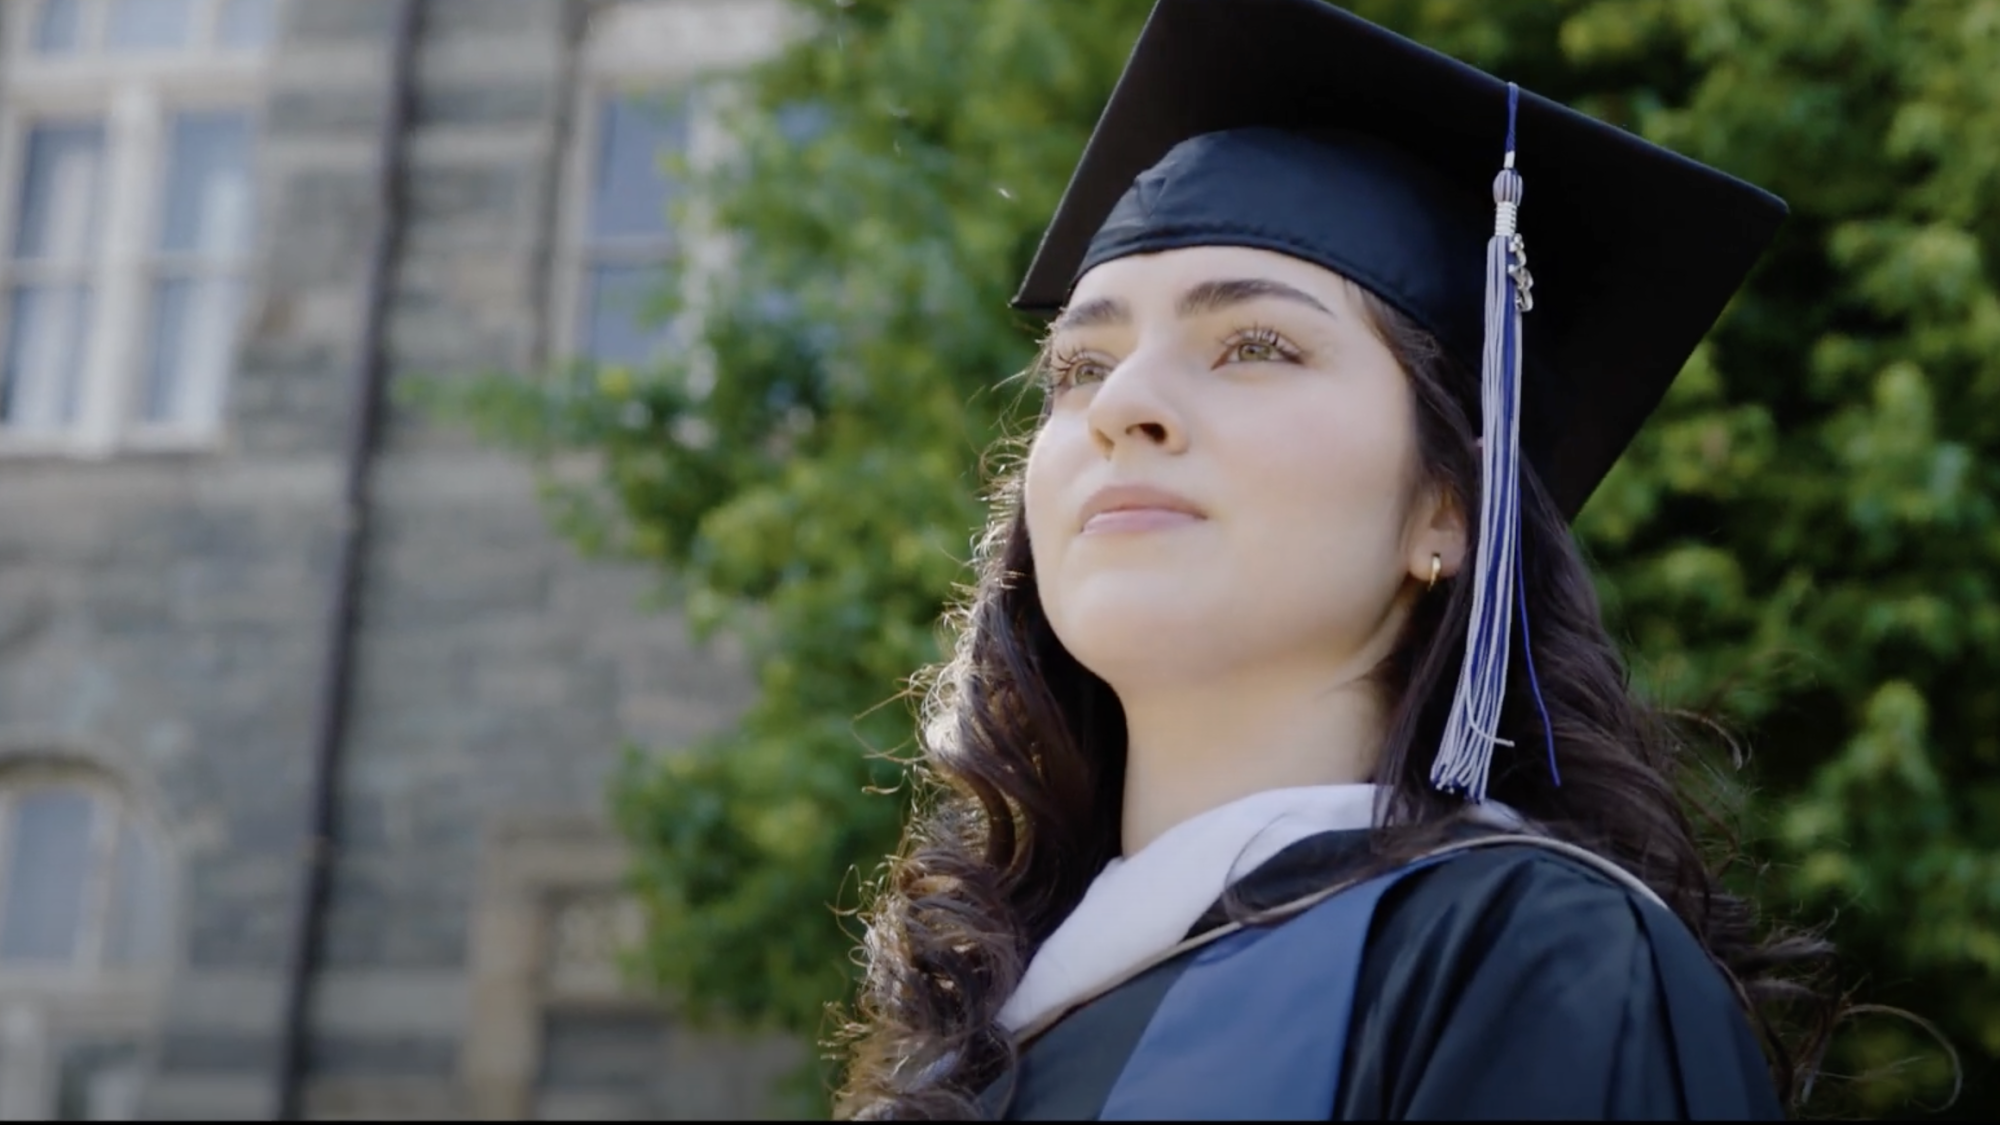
[836,286,1836,1119]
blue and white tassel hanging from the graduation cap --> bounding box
[1430,82,1562,801]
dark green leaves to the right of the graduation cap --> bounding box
[1522,0,2000,1115]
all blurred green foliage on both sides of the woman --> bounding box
[426,0,2000,1117]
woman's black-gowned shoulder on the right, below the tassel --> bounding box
[1350,845,1778,1119]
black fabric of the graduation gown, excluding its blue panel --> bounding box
[980,831,1782,1121]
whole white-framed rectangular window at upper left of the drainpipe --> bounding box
[0,0,278,454]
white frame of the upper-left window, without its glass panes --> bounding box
[0,0,274,458]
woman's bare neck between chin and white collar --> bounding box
[1118,665,1388,855]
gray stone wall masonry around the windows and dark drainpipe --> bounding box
[0,0,790,1119]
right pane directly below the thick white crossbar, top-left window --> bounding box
[160,112,252,256]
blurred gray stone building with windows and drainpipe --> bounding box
[0,0,800,1119]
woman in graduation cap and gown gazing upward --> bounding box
[842,0,1824,1119]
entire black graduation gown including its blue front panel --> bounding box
[980,831,1782,1121]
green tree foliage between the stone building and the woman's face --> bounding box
[430,0,1144,1072]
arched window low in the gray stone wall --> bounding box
[0,767,170,1121]
